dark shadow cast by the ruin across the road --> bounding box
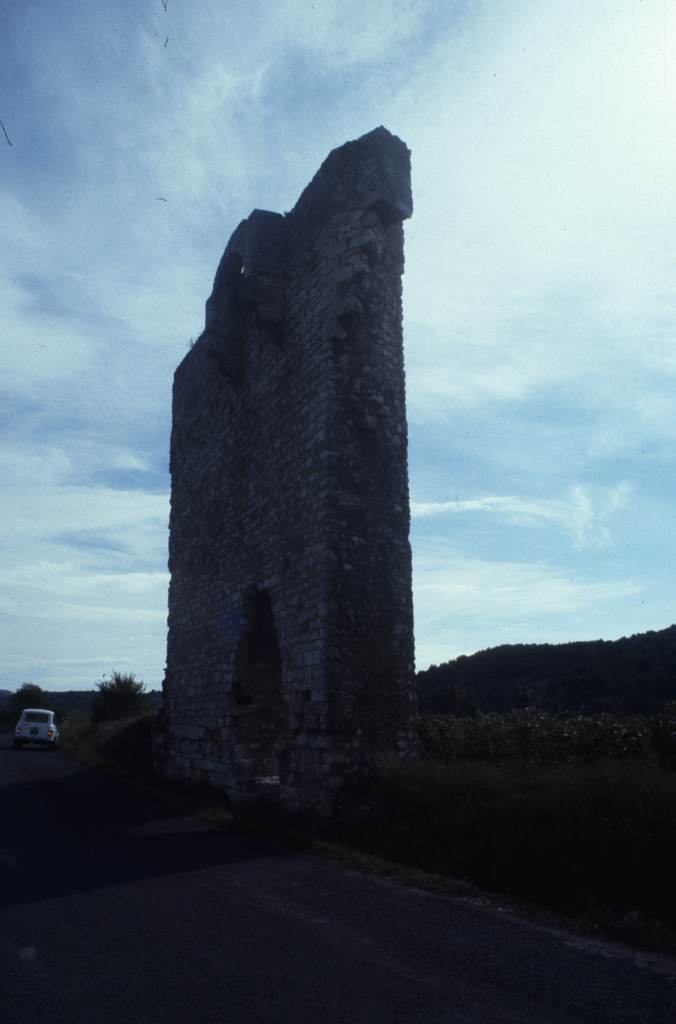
[0,750,288,907]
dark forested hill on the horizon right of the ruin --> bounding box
[418,626,676,715]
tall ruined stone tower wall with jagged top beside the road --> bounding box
[157,128,416,814]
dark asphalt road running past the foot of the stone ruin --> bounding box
[0,737,676,1024]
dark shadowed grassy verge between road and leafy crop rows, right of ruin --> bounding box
[331,761,676,945]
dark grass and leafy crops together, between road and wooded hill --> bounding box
[340,709,676,927]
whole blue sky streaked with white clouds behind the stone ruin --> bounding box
[0,0,676,689]
